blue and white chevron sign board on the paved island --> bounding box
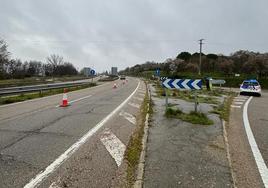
[162,79,202,90]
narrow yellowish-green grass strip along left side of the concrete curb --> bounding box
[125,85,150,187]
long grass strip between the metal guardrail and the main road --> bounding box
[0,83,96,105]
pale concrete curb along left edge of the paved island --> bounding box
[133,88,151,188]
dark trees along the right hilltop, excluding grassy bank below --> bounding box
[121,50,268,78]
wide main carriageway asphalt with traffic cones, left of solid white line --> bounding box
[0,79,144,187]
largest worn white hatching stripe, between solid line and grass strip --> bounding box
[100,130,126,166]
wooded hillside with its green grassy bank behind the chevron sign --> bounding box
[121,50,268,89]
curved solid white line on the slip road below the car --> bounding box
[243,97,268,188]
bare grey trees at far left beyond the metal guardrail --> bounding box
[0,40,78,79]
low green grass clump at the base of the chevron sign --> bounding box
[165,108,213,125]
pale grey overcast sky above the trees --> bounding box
[0,0,268,72]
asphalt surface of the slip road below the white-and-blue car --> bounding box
[227,91,268,187]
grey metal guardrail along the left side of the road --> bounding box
[0,81,91,96]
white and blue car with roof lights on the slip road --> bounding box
[240,80,261,97]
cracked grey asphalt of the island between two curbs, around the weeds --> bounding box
[144,84,232,188]
